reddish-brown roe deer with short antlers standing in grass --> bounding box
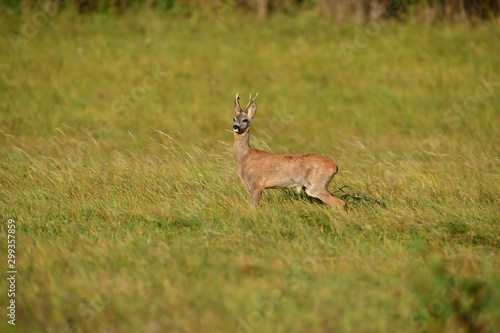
[233,93,345,210]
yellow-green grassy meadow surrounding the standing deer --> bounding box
[0,6,500,333]
